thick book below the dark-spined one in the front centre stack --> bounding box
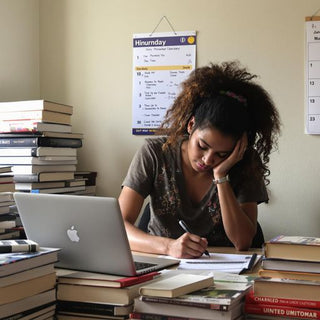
[131,298,243,320]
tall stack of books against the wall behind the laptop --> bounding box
[0,100,85,193]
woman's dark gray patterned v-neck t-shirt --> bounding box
[122,137,268,246]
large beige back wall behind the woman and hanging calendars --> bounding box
[0,0,320,238]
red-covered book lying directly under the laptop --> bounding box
[57,269,160,288]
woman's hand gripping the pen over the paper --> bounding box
[167,232,208,259]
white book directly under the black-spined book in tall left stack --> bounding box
[0,147,77,157]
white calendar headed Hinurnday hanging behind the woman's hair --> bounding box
[132,31,196,135]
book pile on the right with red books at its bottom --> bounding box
[245,235,320,319]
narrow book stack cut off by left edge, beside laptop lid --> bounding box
[0,166,20,240]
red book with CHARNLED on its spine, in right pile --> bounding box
[245,290,320,309]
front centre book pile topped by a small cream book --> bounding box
[130,271,252,320]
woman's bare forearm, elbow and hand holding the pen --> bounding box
[119,187,208,258]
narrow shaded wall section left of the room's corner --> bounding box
[0,0,40,101]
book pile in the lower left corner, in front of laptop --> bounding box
[0,244,58,319]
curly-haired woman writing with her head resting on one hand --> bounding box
[119,62,280,258]
